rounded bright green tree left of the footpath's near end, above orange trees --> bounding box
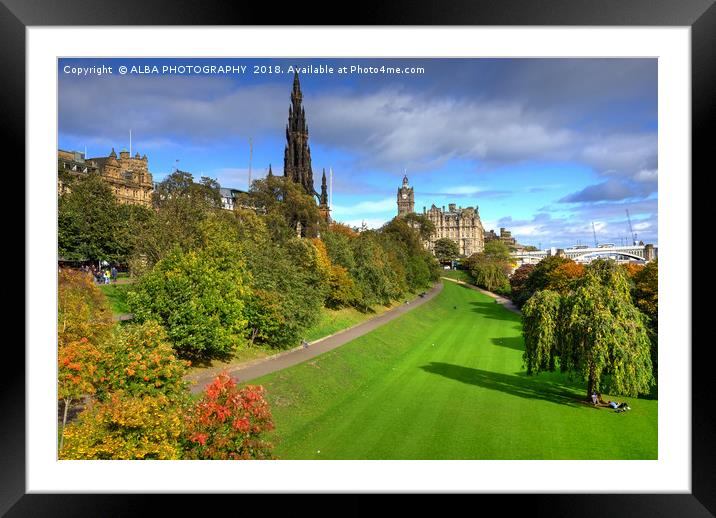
[127,240,249,359]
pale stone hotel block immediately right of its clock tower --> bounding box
[423,203,485,257]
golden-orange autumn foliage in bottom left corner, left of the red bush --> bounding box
[60,321,189,459]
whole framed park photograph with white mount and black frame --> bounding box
[9,0,716,516]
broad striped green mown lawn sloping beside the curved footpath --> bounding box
[251,282,657,459]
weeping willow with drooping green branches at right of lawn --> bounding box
[522,260,654,399]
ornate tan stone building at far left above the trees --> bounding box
[57,148,154,207]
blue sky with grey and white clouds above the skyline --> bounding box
[58,58,658,249]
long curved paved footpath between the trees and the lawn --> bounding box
[185,283,443,394]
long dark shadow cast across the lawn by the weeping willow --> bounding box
[420,362,579,406]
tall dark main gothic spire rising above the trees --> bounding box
[283,73,318,196]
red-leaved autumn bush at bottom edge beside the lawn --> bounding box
[186,372,274,460]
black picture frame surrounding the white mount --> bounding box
[7,0,716,517]
